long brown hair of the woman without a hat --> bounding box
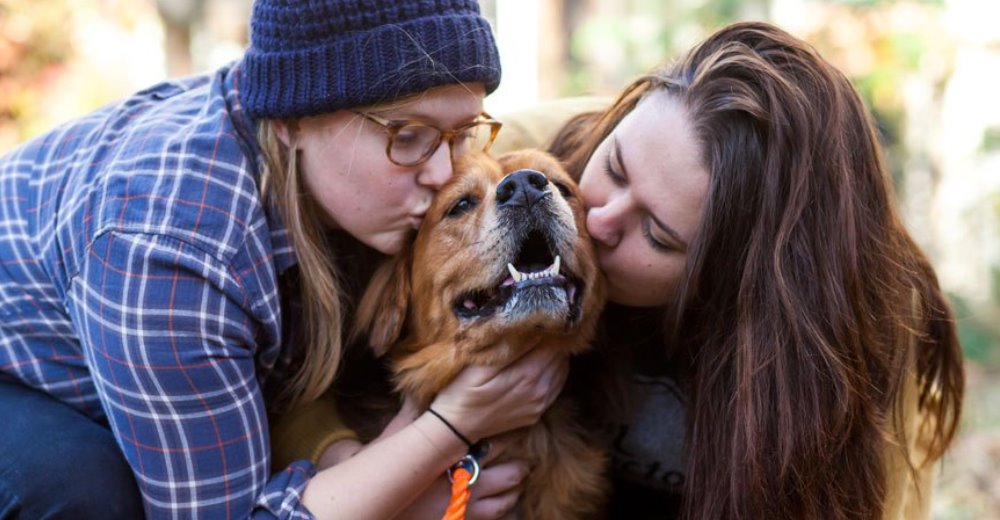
[551,23,964,519]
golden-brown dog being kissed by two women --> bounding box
[358,151,605,520]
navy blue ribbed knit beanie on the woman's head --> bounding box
[240,0,500,119]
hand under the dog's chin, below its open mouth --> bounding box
[431,348,569,442]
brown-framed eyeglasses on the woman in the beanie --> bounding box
[354,111,502,166]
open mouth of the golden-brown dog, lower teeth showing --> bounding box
[454,231,583,324]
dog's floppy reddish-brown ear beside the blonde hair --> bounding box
[351,247,412,357]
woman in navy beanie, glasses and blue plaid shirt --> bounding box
[0,0,566,519]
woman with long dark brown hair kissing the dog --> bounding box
[552,23,964,519]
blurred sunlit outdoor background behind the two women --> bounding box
[0,0,1000,519]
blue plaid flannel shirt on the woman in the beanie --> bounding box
[0,63,315,518]
